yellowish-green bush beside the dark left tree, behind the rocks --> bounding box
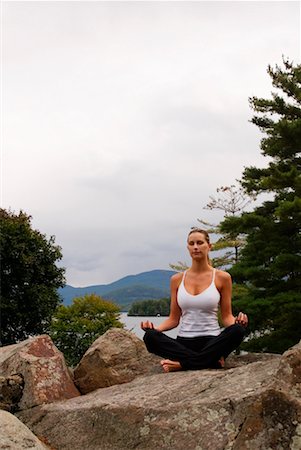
[49,294,123,366]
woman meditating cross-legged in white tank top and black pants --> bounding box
[141,228,248,372]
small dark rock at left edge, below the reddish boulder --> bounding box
[0,374,24,412]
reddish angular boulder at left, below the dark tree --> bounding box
[0,335,80,409]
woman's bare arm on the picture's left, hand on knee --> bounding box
[141,273,183,331]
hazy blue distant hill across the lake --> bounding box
[59,270,175,311]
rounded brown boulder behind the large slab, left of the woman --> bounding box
[74,328,162,394]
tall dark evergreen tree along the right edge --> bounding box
[221,60,301,352]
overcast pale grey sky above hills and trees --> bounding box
[1,1,300,286]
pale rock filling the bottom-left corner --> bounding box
[0,411,49,450]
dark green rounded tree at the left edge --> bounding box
[0,209,65,345]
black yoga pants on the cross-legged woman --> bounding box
[143,324,245,370]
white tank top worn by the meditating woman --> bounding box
[177,269,221,337]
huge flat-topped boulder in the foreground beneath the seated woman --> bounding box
[18,345,301,450]
